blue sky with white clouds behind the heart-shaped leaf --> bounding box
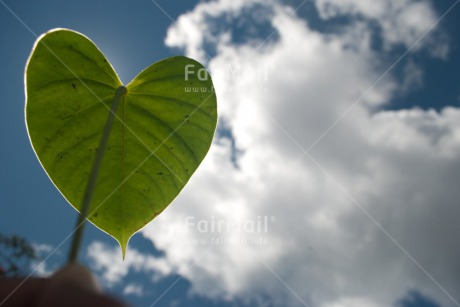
[0,0,460,307]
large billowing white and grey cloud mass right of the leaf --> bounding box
[139,0,460,307]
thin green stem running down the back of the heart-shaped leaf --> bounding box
[68,86,127,264]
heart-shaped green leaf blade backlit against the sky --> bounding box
[25,29,217,257]
